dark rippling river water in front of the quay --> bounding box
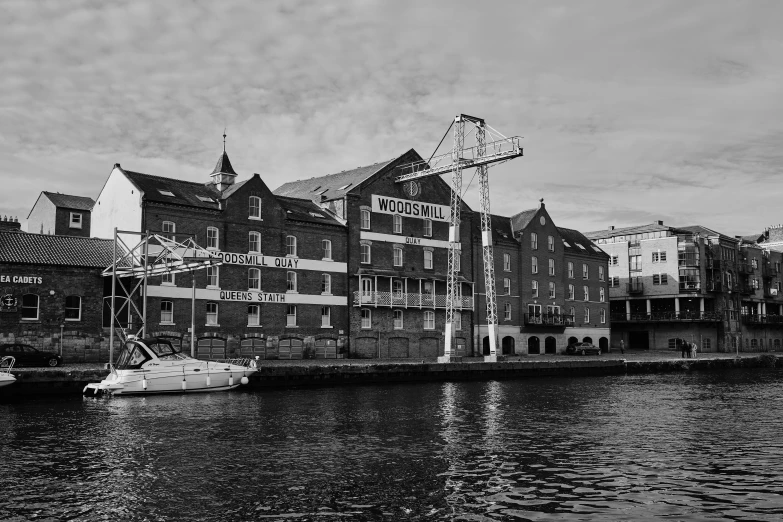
[0,369,783,521]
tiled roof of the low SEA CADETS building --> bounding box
[0,231,114,268]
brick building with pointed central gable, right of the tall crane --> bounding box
[473,200,610,355]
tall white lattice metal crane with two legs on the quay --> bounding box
[395,114,522,362]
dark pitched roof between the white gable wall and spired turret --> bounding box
[123,169,221,210]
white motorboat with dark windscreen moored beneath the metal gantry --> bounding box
[83,338,257,395]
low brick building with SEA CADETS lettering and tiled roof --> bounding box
[0,231,113,362]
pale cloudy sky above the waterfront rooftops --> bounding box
[0,0,783,235]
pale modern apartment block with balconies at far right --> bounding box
[588,221,783,352]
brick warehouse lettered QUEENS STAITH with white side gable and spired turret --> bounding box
[93,146,347,358]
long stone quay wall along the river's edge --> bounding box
[0,352,783,397]
